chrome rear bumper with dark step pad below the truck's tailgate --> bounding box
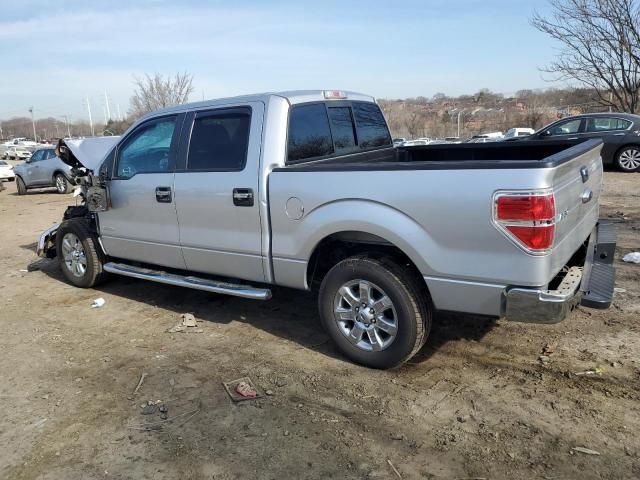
[505,223,616,323]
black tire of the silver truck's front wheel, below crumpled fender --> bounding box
[56,218,107,288]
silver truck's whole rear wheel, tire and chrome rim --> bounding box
[318,257,431,368]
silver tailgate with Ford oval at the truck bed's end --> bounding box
[548,140,603,278]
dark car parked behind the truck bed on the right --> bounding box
[510,113,640,172]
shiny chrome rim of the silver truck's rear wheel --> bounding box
[333,279,398,352]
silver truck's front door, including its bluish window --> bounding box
[98,115,185,269]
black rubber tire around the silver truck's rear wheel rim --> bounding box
[318,256,432,369]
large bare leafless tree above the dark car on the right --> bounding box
[531,0,640,113]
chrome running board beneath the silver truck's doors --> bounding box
[102,262,271,300]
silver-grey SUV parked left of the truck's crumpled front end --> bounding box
[14,147,73,195]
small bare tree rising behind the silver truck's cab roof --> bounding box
[130,72,193,118]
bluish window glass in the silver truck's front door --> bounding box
[116,117,176,178]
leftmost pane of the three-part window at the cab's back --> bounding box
[287,103,333,163]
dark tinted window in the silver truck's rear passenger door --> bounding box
[187,109,251,171]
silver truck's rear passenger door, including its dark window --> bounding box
[175,102,265,281]
